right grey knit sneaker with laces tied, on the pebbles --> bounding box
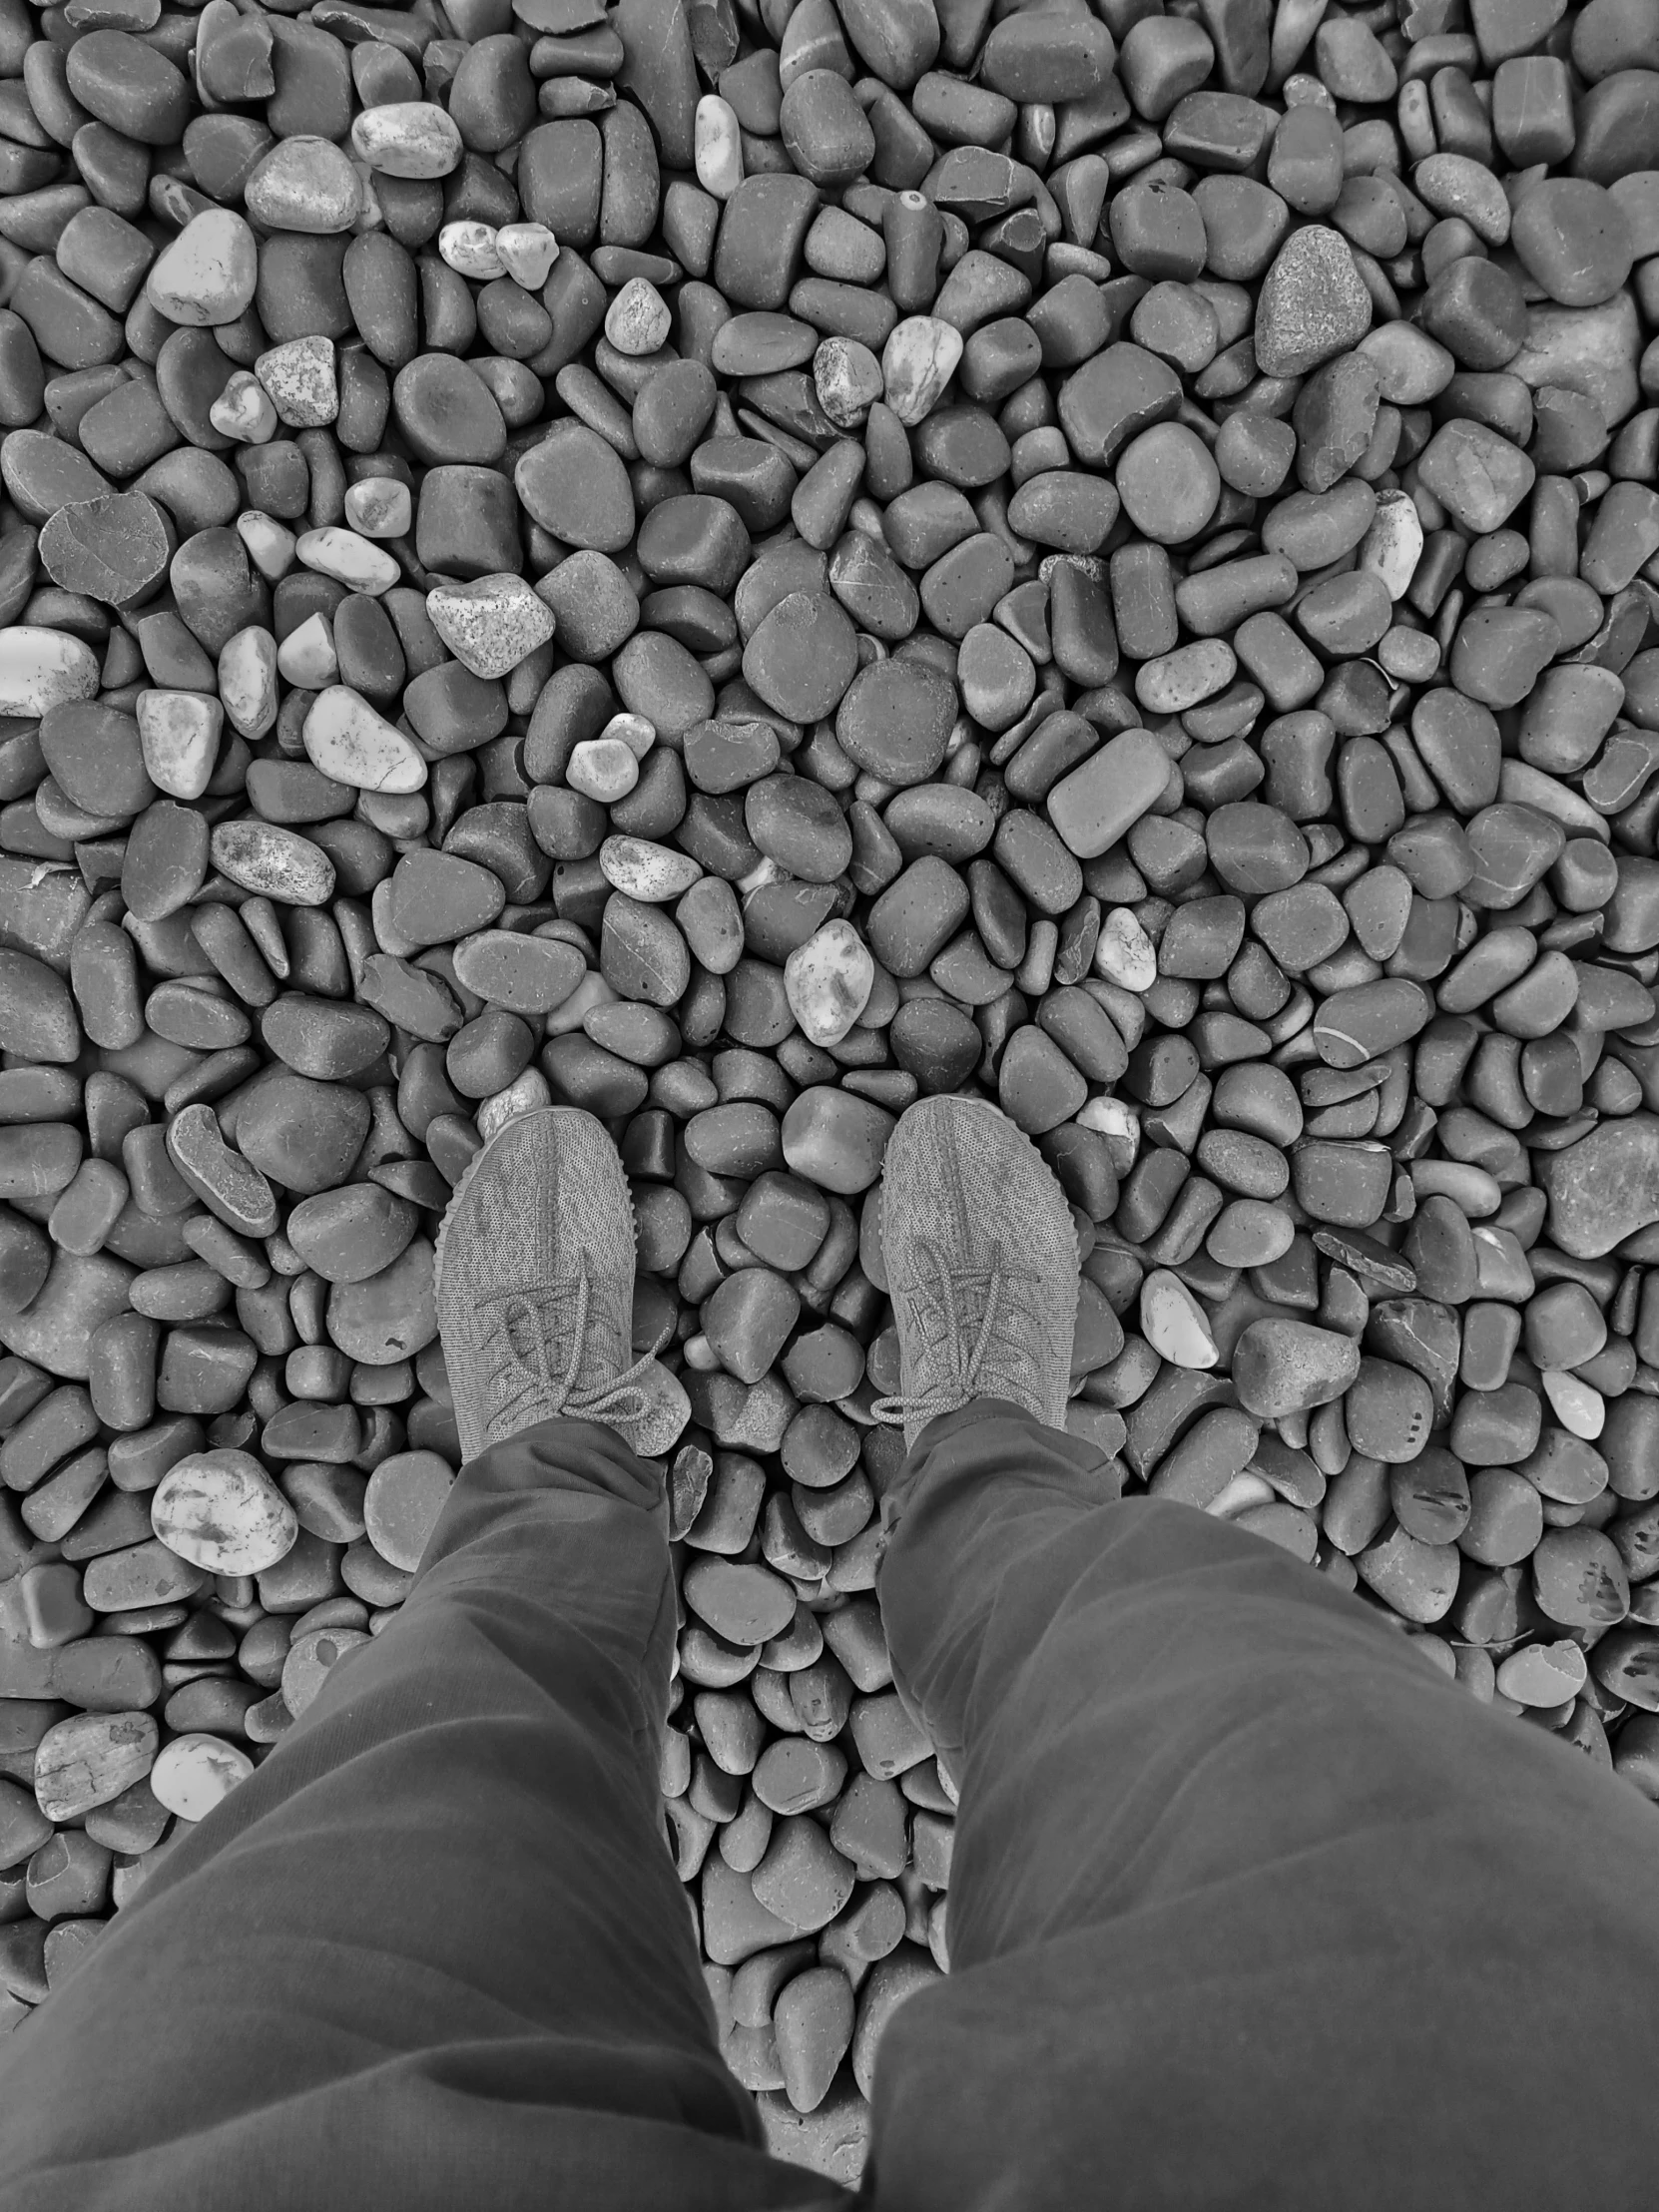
[873,1097,1077,1446]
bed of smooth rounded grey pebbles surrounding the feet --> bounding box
[0,0,1659,2181]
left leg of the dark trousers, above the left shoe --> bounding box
[0,1420,849,2212]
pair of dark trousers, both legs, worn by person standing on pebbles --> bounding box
[0,1402,1659,2212]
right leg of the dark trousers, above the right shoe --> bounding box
[867,1402,1659,2212]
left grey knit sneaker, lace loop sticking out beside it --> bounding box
[436,1106,690,1460]
